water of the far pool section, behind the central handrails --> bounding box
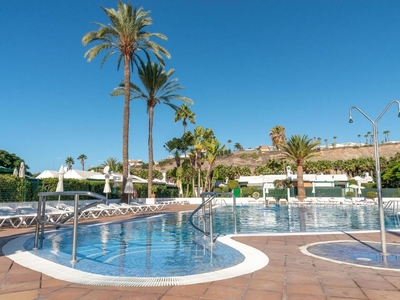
[203,205,400,234]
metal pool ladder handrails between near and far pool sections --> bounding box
[189,192,237,244]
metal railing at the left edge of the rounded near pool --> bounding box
[34,191,107,263]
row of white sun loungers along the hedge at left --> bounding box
[0,203,165,228]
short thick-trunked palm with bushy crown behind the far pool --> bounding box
[281,135,319,202]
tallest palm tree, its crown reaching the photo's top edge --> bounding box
[82,0,170,202]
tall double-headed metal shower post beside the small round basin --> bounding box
[349,100,400,255]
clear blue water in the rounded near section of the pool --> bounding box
[24,214,244,277]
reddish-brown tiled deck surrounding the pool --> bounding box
[0,205,400,300]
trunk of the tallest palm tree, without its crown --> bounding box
[121,56,131,203]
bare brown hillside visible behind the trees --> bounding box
[154,142,400,172]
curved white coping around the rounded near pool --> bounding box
[3,234,269,287]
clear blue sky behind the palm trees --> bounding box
[0,0,400,173]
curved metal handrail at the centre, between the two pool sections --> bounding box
[189,192,237,244]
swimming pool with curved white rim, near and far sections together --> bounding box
[3,205,399,286]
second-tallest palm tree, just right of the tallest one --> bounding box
[111,59,193,197]
